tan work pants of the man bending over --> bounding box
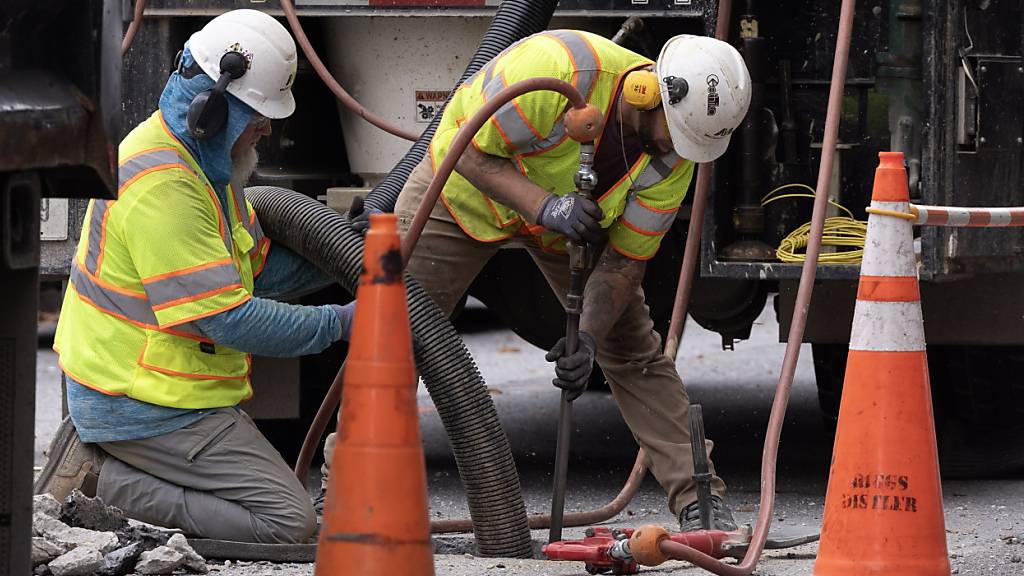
[326,160,725,515]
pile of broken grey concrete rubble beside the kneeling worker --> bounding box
[32,490,208,576]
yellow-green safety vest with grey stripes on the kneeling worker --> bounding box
[53,111,269,408]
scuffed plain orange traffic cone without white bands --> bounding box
[314,214,434,576]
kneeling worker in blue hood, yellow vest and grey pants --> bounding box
[36,10,353,543]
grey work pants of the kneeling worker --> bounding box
[96,408,316,543]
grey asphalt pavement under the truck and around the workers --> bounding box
[36,306,1024,576]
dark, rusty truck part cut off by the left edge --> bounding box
[0,0,123,574]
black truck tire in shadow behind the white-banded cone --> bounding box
[811,344,1024,478]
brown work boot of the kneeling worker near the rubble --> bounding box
[33,417,106,502]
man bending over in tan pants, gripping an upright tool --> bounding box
[328,30,750,531]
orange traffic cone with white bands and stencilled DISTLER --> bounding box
[814,152,949,576]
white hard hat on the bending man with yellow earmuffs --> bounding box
[654,34,751,162]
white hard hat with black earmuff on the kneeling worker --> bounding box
[188,10,296,118]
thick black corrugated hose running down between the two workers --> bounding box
[246,0,557,558]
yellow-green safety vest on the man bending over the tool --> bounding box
[430,30,693,259]
